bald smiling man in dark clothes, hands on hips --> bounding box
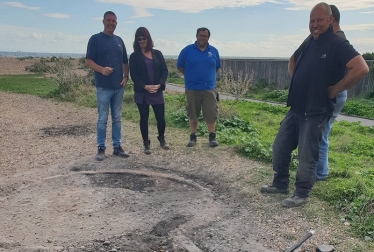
[260,2,369,207]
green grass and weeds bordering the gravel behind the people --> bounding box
[0,57,374,244]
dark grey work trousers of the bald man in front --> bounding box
[273,110,330,198]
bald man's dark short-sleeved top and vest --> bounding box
[287,26,359,115]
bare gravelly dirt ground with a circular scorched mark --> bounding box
[0,58,368,252]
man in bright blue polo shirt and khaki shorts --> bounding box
[177,27,221,147]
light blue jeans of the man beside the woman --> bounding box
[96,87,125,148]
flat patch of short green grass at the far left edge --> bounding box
[0,74,57,97]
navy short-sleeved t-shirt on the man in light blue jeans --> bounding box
[86,32,128,88]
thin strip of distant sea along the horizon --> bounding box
[0,51,288,60]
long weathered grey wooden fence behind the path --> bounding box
[221,59,374,98]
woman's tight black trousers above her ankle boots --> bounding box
[136,103,166,141]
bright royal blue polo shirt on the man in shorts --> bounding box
[177,42,221,90]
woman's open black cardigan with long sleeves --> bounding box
[130,49,168,93]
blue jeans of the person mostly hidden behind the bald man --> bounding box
[316,90,347,179]
